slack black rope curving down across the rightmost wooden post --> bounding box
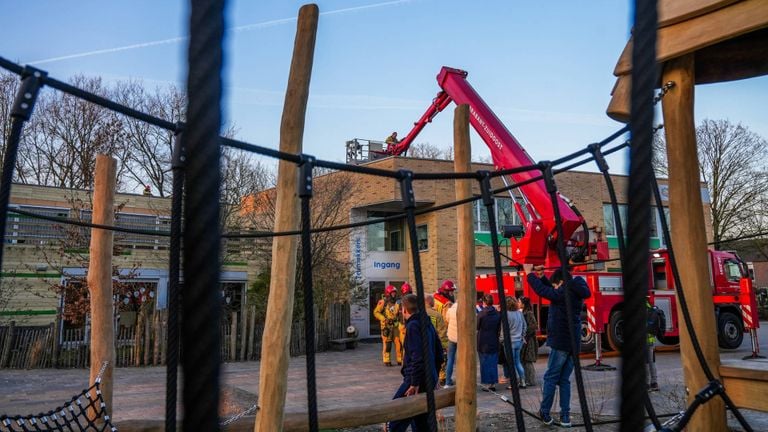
[651,176,752,432]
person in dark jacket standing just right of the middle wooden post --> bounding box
[477,294,501,391]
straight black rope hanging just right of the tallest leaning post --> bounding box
[299,155,318,432]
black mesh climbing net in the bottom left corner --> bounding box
[0,363,117,432]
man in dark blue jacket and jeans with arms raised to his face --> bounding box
[528,266,590,427]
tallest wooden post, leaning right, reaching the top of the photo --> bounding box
[254,4,319,432]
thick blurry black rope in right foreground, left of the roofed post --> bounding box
[619,0,657,431]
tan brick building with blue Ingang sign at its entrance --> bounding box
[286,157,712,337]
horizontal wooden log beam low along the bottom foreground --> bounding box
[115,388,456,432]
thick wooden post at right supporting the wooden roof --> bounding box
[662,54,727,431]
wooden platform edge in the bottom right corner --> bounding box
[720,359,768,411]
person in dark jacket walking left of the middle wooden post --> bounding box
[387,294,443,432]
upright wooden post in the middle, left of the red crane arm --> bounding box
[453,105,477,432]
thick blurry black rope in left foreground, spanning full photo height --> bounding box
[181,0,224,431]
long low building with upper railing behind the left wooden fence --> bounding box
[0,184,253,325]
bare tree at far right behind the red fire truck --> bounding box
[654,119,768,247]
